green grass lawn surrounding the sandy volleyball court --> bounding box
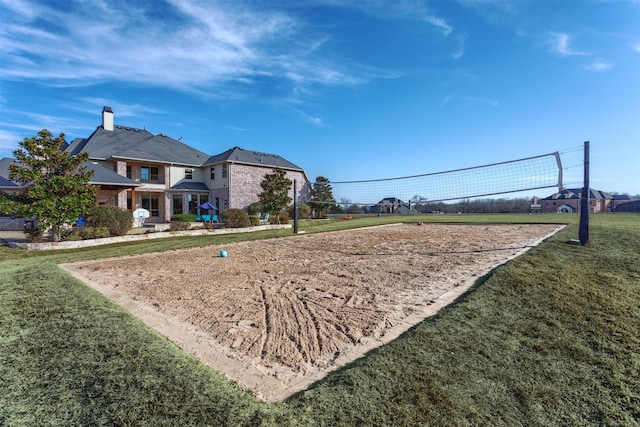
[0,214,640,426]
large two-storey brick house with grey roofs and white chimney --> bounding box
[0,107,311,227]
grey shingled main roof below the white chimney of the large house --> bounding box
[68,125,209,167]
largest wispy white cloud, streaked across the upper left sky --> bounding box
[0,0,378,95]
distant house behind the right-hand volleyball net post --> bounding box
[540,188,640,213]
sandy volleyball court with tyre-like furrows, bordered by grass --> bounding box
[63,224,562,401]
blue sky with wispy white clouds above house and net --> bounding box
[0,0,640,196]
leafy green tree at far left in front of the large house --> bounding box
[0,129,97,242]
